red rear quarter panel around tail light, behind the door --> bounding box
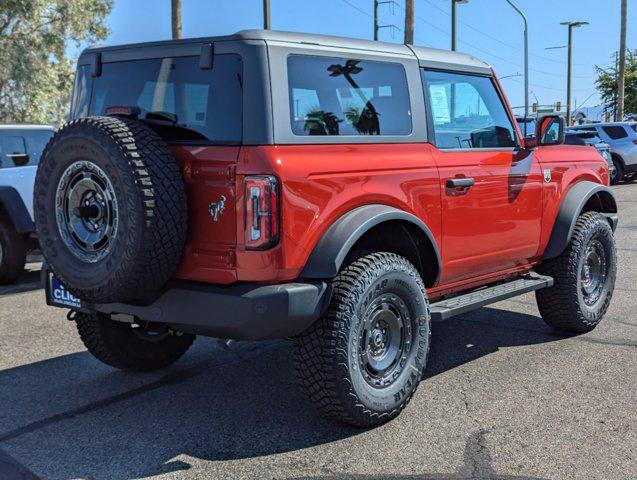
[237,143,441,281]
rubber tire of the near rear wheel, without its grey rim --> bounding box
[294,252,431,427]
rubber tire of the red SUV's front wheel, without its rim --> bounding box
[535,212,617,333]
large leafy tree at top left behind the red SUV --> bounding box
[0,0,113,124]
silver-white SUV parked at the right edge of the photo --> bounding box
[571,122,637,183]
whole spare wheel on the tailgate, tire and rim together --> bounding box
[34,117,187,303]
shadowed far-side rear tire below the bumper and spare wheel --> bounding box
[74,312,195,372]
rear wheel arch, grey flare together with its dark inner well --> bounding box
[300,204,441,287]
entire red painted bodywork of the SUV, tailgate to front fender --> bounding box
[172,143,608,297]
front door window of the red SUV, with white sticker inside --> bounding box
[423,71,517,149]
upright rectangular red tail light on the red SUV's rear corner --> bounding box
[245,175,279,250]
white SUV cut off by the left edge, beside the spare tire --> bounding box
[0,125,54,285]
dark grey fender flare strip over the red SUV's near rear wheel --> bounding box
[300,204,442,283]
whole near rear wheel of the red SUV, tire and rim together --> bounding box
[295,253,431,427]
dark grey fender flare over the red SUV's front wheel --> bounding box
[542,180,618,260]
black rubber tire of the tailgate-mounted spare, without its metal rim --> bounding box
[34,117,187,303]
